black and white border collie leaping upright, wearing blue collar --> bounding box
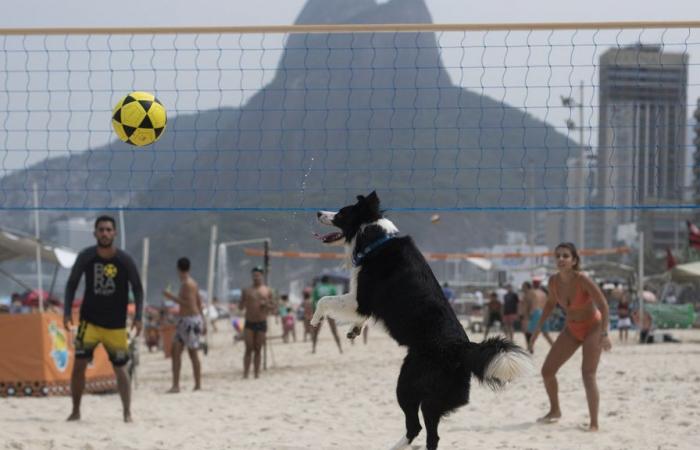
[311,192,531,449]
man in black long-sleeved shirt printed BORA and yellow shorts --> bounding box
[63,216,143,422]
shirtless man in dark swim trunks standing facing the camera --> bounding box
[238,267,274,378]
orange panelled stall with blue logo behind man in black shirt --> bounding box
[0,313,116,397]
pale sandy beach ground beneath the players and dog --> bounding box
[0,319,700,449]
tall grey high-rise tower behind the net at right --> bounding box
[591,44,688,247]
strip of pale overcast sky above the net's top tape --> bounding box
[0,0,698,27]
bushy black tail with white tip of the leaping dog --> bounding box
[466,337,533,390]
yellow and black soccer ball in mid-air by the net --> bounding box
[112,91,168,147]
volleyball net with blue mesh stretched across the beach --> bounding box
[0,23,700,211]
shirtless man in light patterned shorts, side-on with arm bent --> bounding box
[163,258,206,394]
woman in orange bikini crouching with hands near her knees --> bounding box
[530,242,611,431]
